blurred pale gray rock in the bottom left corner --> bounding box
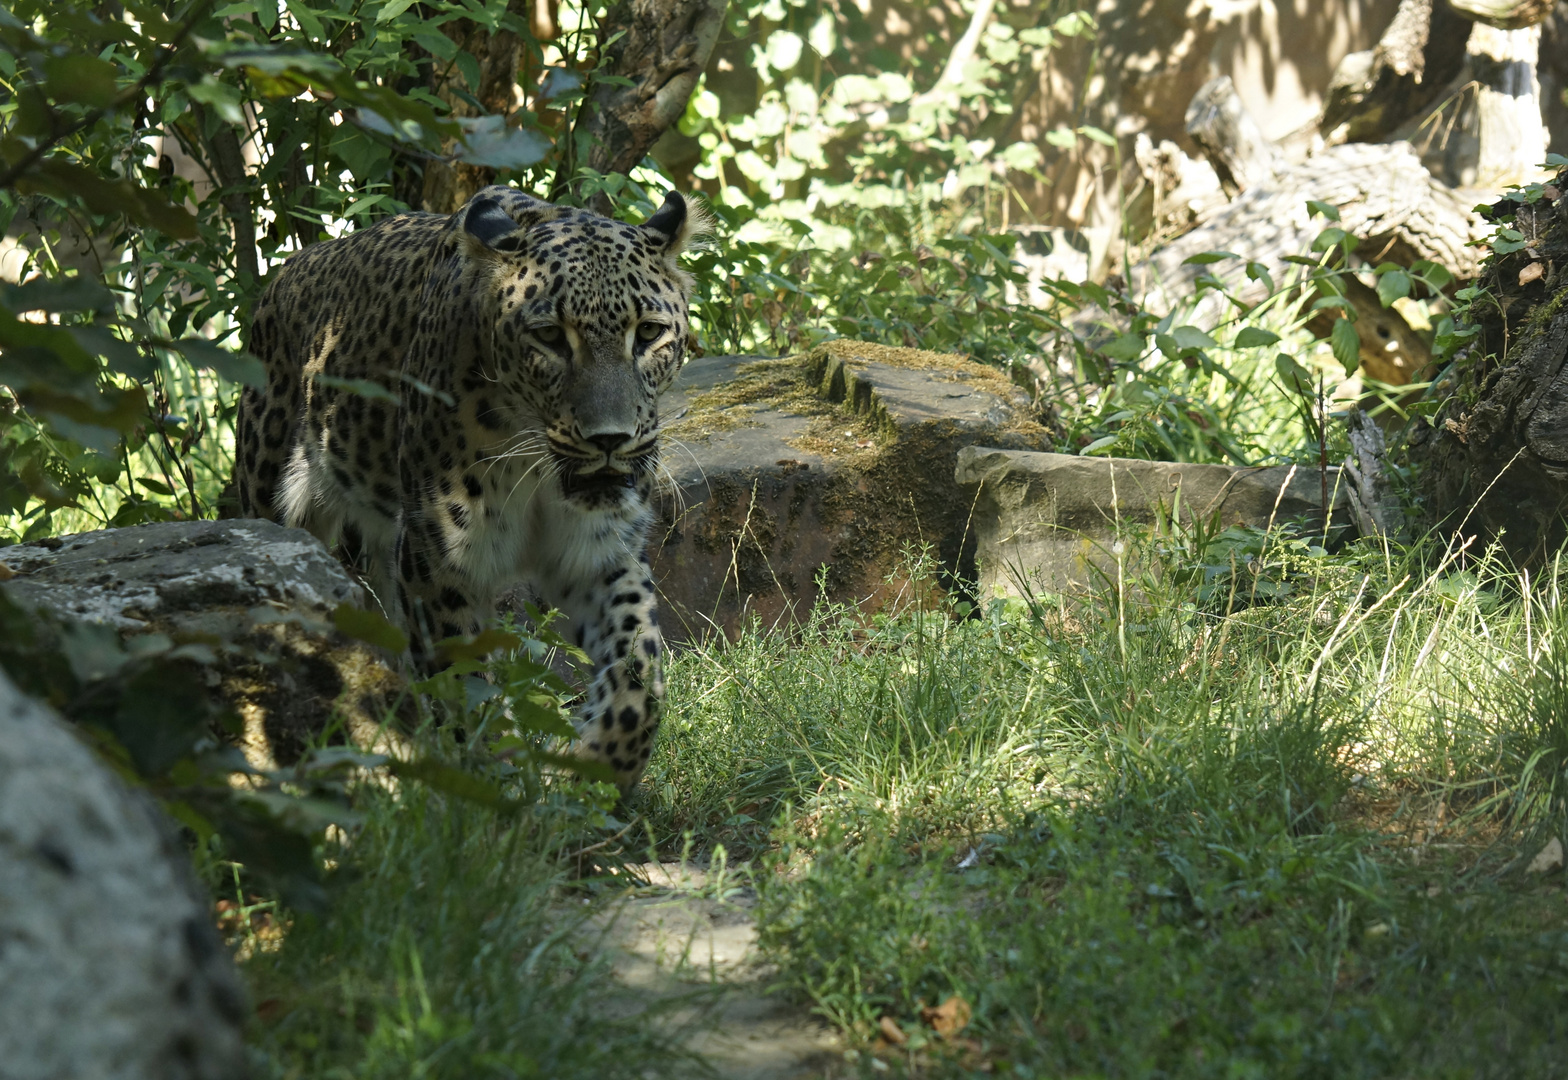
[0,674,246,1080]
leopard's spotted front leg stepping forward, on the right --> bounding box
[539,555,665,792]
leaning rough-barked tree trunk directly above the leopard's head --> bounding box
[573,0,726,212]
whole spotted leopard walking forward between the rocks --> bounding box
[235,187,704,790]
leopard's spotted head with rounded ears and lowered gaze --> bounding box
[461,188,706,508]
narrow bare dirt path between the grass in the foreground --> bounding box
[591,864,845,1080]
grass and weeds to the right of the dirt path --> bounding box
[644,536,1568,1077]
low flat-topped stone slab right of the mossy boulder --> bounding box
[953,447,1348,596]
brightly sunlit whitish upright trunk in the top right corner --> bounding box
[1469,22,1546,190]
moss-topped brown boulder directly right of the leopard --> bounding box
[651,340,1049,640]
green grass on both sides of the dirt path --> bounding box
[228,531,1568,1078]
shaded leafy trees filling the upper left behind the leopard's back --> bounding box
[0,0,711,539]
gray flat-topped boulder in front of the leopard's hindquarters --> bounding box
[0,519,409,770]
